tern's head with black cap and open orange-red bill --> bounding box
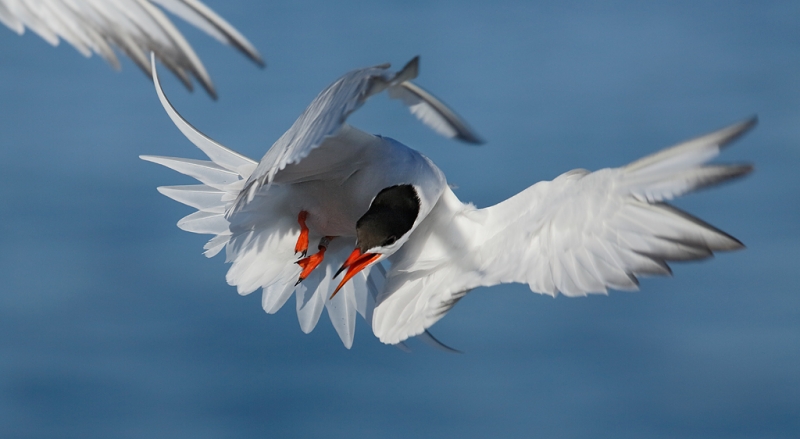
[331,184,420,297]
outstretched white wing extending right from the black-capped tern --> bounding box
[373,118,756,343]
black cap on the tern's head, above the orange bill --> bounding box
[356,184,420,253]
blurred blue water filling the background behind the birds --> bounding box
[0,0,800,439]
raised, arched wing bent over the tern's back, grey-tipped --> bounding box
[234,57,480,210]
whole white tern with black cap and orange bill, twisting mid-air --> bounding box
[142,55,756,347]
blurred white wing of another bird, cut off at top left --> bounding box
[0,0,264,99]
